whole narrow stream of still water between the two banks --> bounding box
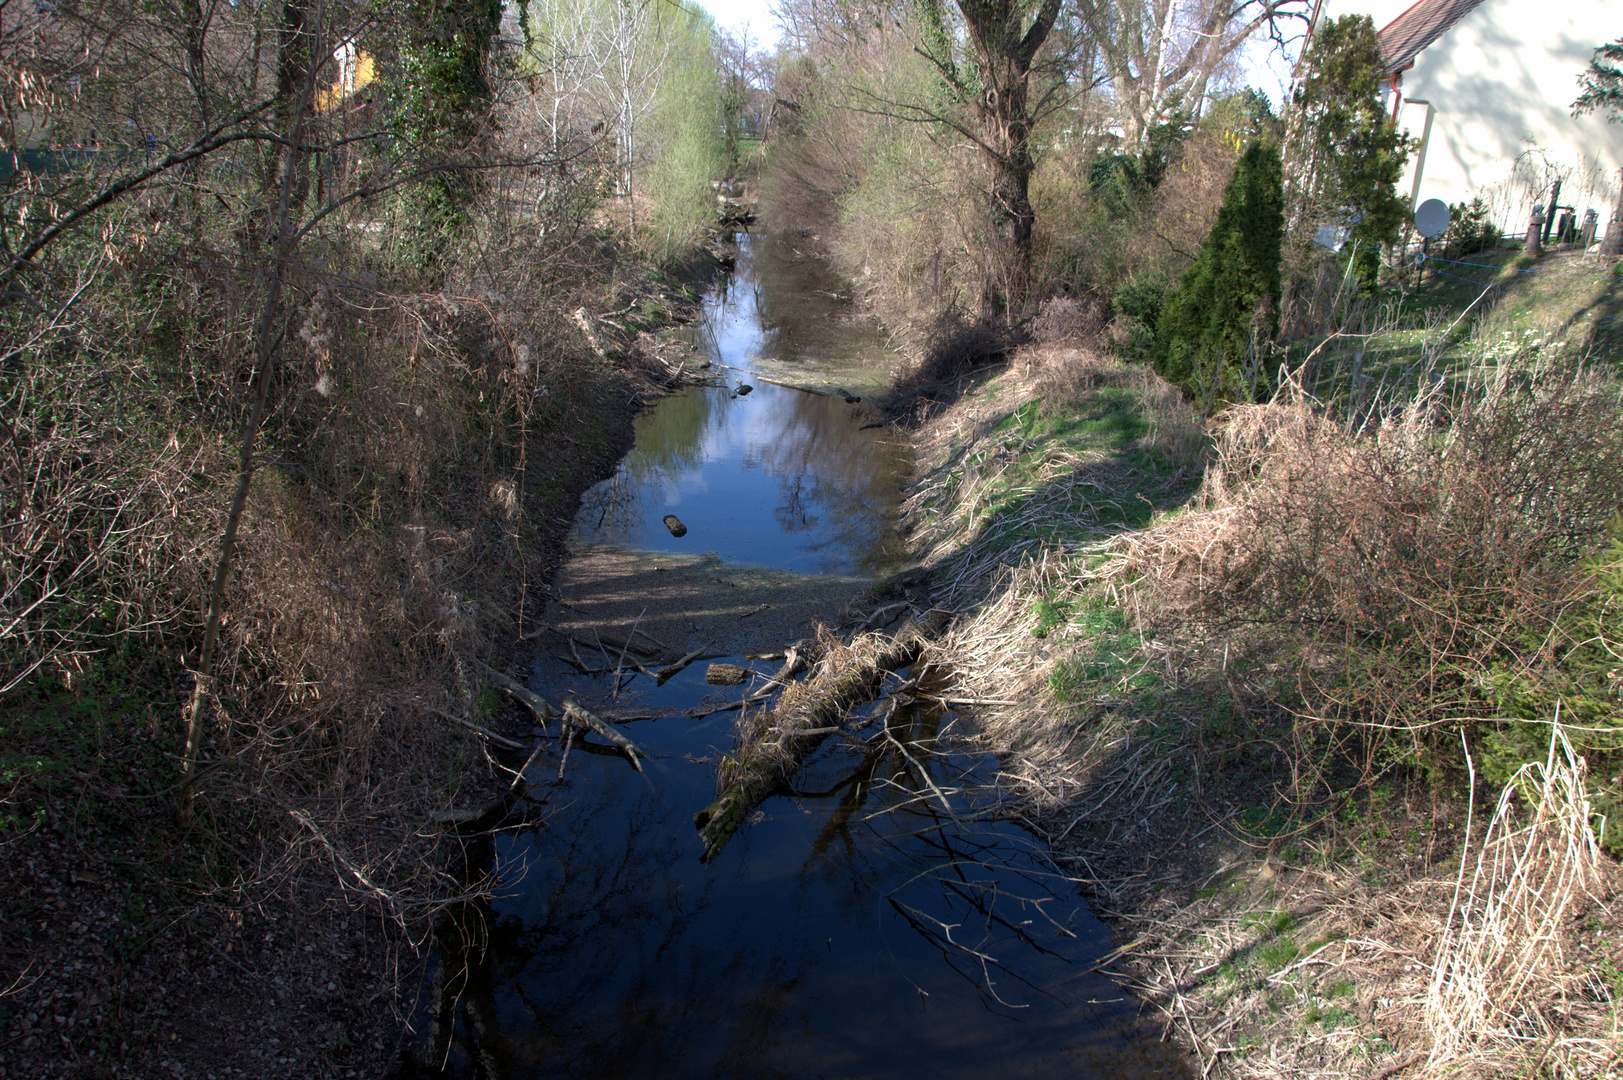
[419,235,1188,1080]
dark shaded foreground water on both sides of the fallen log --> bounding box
[440,689,1182,1078]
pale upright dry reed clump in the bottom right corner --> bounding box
[1425,723,1617,1075]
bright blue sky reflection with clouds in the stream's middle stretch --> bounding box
[575,232,907,573]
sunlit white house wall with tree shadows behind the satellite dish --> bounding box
[1334,0,1623,234]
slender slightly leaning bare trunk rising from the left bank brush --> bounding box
[175,0,323,827]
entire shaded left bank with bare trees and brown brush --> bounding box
[0,0,756,1077]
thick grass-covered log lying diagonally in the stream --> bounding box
[693,611,951,862]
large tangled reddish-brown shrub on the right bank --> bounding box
[1117,370,1623,765]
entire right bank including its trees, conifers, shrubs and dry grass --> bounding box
[763,0,1623,1077]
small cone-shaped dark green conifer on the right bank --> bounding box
[1156,143,1285,413]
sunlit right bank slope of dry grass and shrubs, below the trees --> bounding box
[912,254,1623,1075]
